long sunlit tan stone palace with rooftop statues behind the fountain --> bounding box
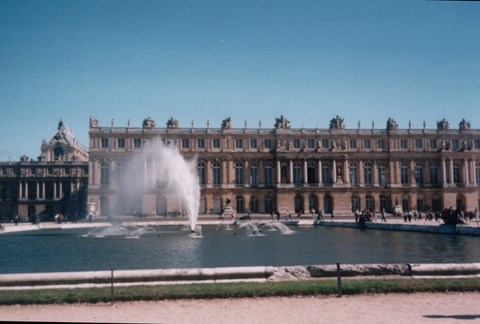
[87,116,480,216]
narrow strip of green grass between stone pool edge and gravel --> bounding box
[0,279,480,305]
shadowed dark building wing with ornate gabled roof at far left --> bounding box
[0,121,88,221]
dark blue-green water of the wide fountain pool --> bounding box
[0,223,480,273]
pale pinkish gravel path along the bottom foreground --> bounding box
[0,293,480,324]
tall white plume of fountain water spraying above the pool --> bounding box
[126,139,200,232]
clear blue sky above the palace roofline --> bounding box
[0,0,480,161]
